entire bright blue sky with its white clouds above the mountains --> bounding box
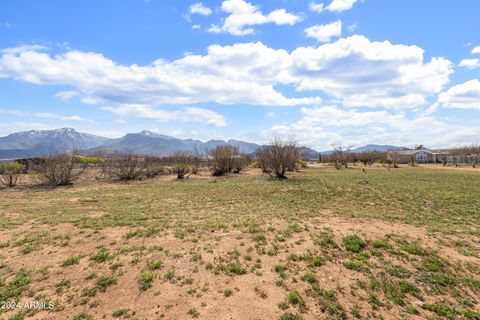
[0,0,480,150]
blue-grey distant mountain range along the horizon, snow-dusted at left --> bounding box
[0,128,404,159]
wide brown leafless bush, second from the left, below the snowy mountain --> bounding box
[39,152,84,186]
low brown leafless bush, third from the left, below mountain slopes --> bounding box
[105,155,145,181]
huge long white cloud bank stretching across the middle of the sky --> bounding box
[0,36,453,108]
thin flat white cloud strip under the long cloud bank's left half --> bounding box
[102,104,227,127]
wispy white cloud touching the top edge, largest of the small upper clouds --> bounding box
[208,0,301,36]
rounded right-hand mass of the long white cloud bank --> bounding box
[291,35,453,108]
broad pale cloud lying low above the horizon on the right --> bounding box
[260,105,480,150]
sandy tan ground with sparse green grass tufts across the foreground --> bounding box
[0,166,480,320]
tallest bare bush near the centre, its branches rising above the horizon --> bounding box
[257,139,300,179]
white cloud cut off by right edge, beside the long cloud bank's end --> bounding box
[438,79,480,110]
